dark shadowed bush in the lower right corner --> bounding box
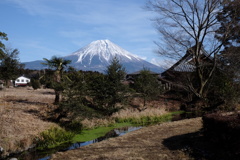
[203,113,240,155]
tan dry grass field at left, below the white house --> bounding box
[0,88,56,155]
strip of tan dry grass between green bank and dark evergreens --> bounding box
[81,97,181,129]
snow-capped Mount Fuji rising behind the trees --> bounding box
[24,40,163,73]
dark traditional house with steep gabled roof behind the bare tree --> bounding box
[126,47,213,91]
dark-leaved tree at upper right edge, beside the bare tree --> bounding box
[216,0,240,76]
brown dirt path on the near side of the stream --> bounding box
[52,118,202,160]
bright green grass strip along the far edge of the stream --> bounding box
[37,111,186,150]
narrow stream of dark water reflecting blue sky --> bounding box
[8,127,142,160]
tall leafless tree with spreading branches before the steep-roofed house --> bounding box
[147,0,231,98]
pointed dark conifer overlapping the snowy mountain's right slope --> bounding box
[88,58,127,115]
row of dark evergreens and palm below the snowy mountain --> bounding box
[36,57,162,119]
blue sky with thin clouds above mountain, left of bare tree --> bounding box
[0,0,169,67]
